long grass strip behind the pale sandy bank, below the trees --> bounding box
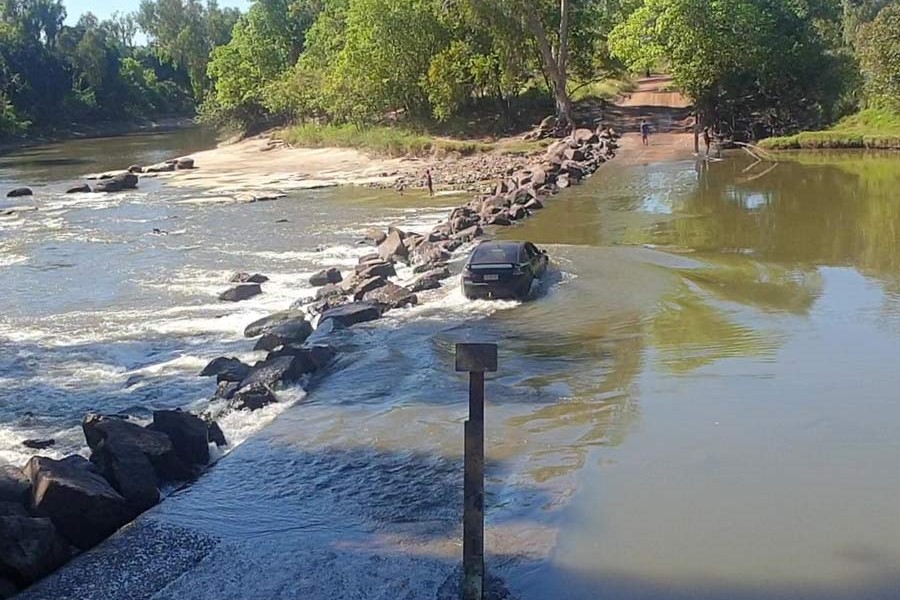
[278,123,546,157]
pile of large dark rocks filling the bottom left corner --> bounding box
[0,410,225,598]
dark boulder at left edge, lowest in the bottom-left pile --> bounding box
[0,516,69,587]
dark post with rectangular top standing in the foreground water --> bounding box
[456,344,497,600]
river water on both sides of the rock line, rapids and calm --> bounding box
[0,134,900,600]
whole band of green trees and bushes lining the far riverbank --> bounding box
[0,0,900,147]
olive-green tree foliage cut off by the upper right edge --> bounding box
[858,2,900,112]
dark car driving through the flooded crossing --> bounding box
[462,242,548,300]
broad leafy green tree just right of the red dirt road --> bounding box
[610,0,849,133]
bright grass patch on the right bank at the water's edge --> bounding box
[759,108,900,150]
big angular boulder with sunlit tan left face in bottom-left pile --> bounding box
[25,456,132,550]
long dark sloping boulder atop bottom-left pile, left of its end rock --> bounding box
[81,414,193,481]
